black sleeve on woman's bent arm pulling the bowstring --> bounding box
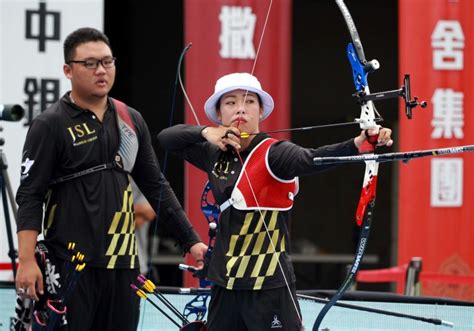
[158,124,213,173]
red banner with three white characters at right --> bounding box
[398,0,474,300]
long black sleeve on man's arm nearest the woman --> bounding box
[132,112,200,252]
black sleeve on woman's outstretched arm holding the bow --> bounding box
[268,139,358,179]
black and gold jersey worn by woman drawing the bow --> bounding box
[159,125,358,290]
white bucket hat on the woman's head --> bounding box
[204,72,274,124]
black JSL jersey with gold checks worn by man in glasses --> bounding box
[16,94,199,269]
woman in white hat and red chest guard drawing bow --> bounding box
[158,73,393,331]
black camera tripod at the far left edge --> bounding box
[0,150,18,278]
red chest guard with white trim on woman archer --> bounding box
[221,138,298,211]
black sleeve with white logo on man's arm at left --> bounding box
[16,118,58,232]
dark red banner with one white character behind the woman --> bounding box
[184,0,292,286]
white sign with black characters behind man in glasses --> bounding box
[0,0,104,280]
